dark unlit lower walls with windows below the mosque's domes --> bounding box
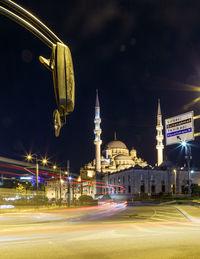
[103,166,193,200]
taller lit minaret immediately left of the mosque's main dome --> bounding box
[94,90,102,172]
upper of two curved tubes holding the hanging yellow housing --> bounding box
[0,0,63,43]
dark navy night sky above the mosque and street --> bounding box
[0,0,200,173]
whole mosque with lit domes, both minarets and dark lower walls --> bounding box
[80,92,195,200]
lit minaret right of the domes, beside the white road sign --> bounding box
[156,99,164,166]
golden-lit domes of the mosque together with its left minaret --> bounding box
[81,92,148,181]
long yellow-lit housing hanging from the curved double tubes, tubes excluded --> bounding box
[39,42,75,136]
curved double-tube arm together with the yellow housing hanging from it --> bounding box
[0,0,75,137]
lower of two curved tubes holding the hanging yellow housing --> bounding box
[0,6,54,48]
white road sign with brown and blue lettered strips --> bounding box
[165,111,194,145]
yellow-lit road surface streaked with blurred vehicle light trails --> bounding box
[0,204,200,259]
